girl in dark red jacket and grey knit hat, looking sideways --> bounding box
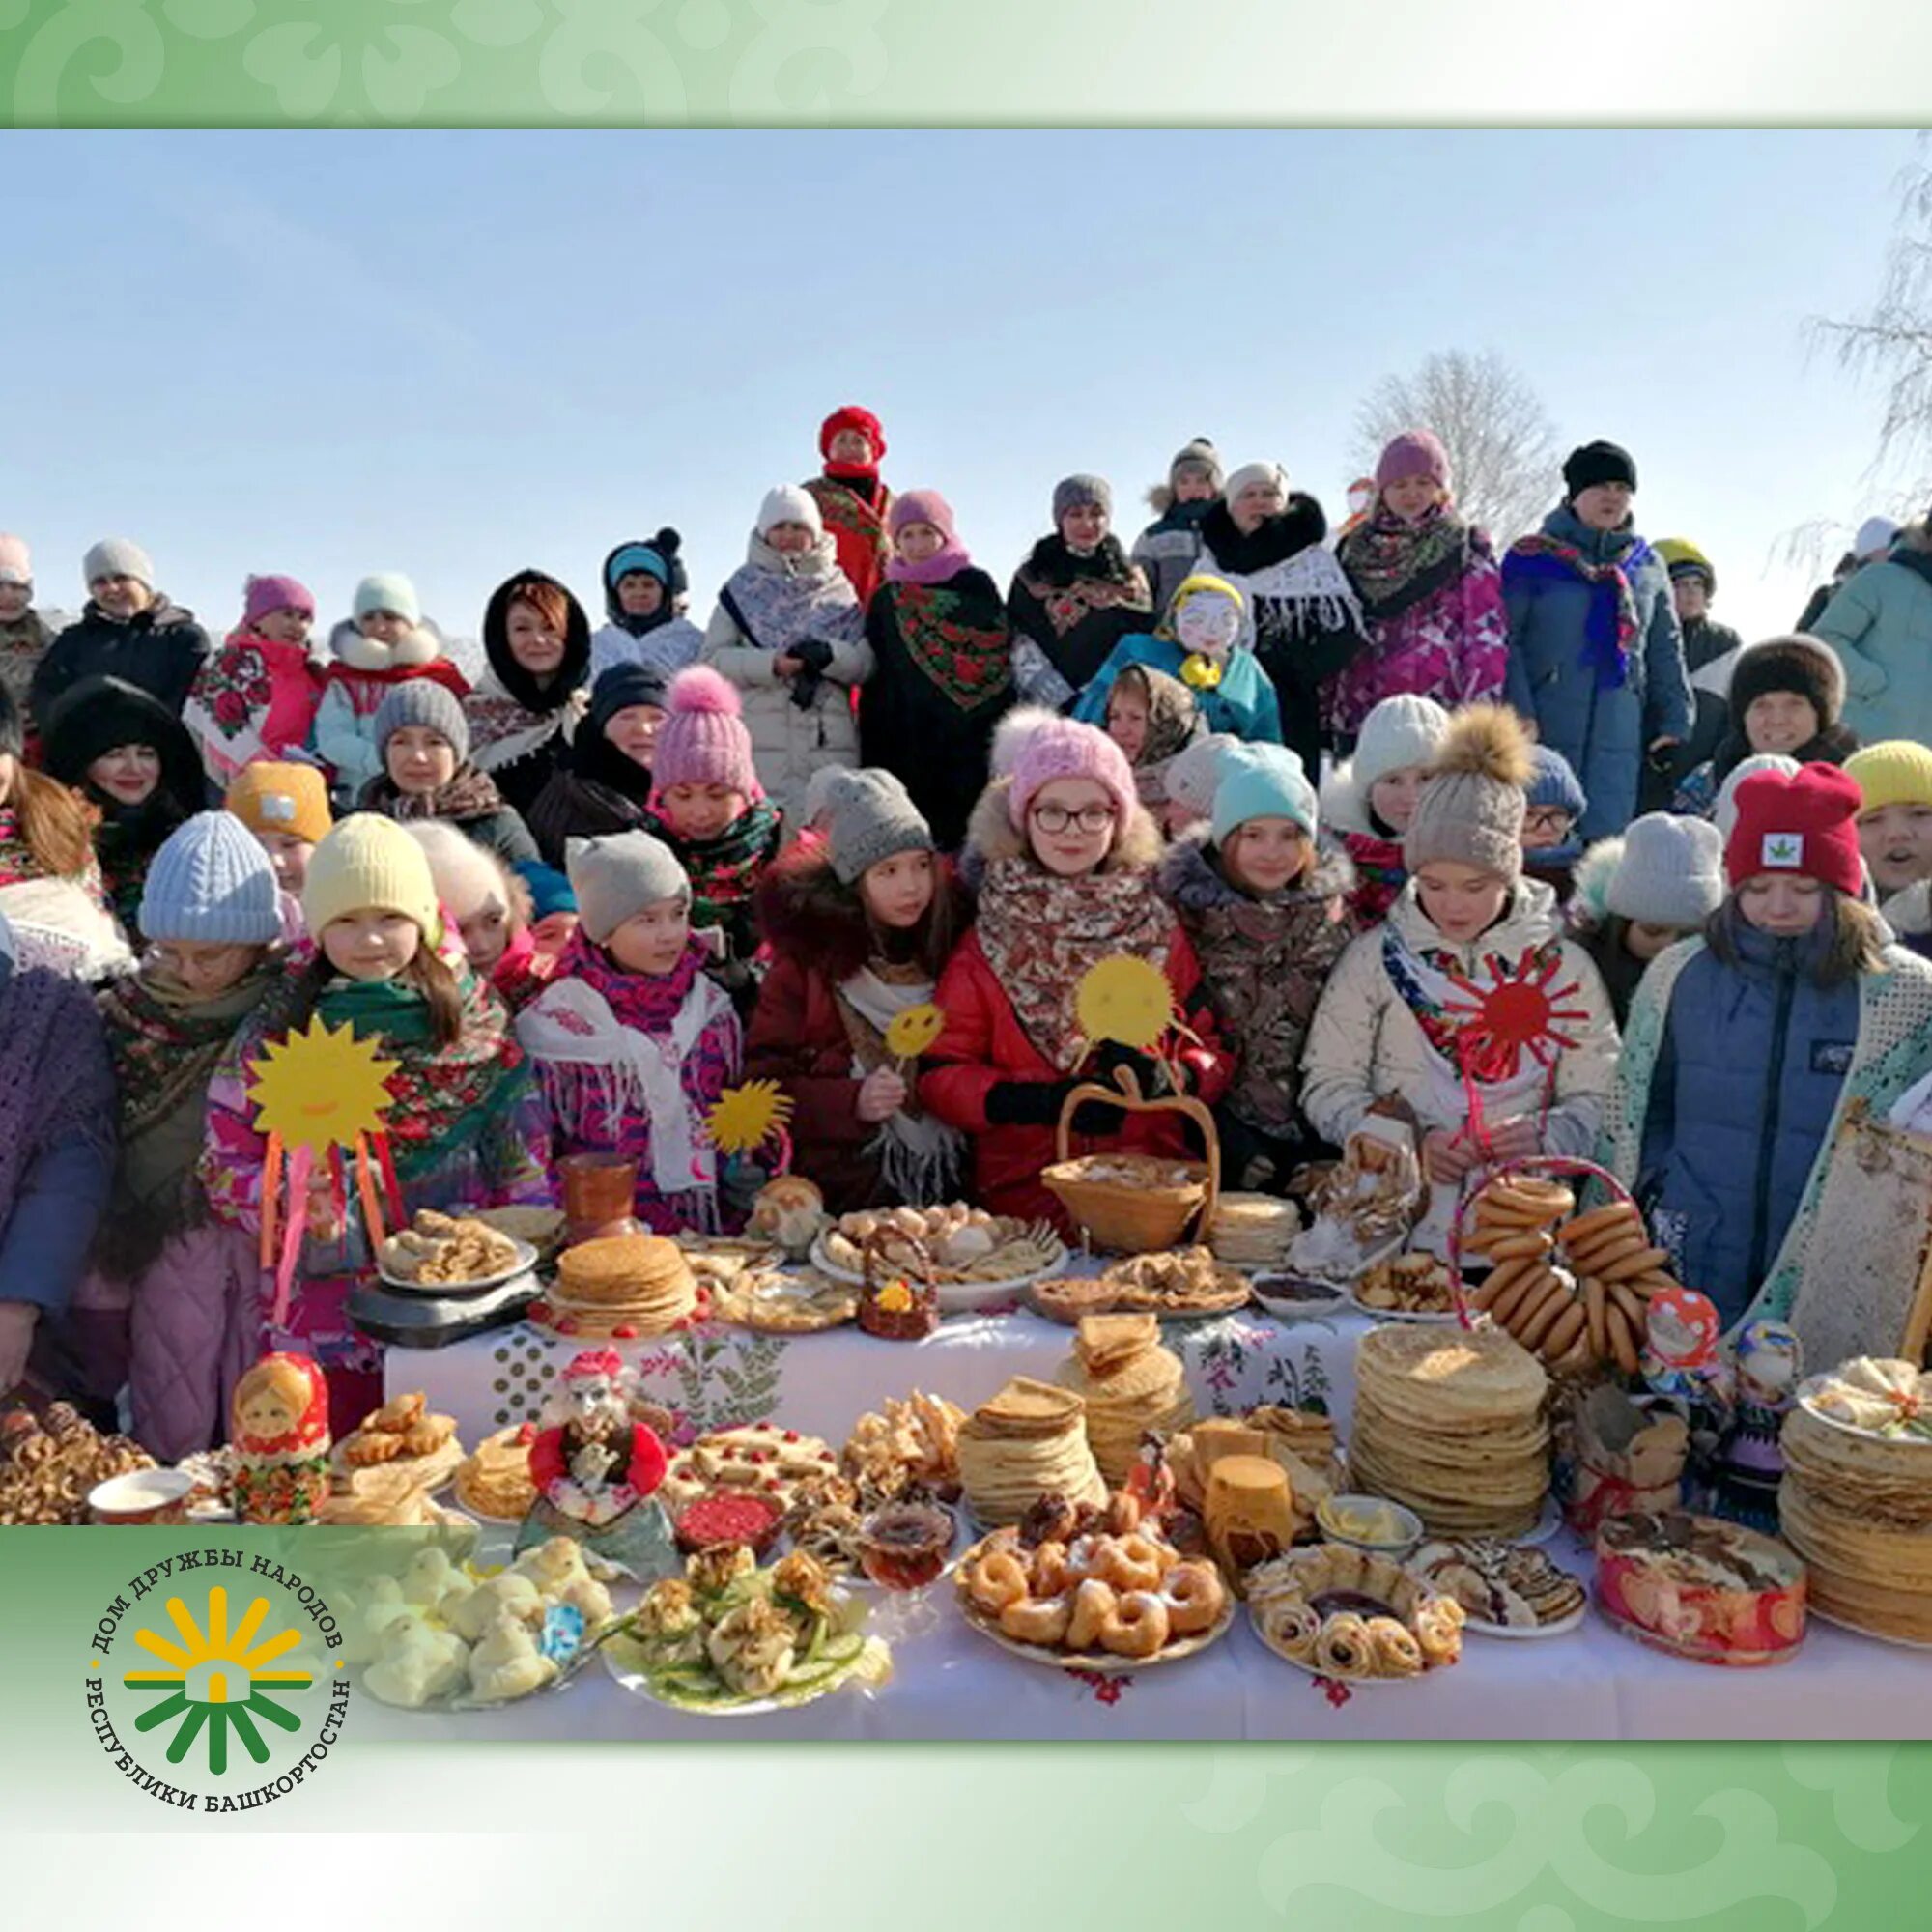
[744,767,970,1213]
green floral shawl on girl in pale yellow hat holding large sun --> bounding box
[315,968,524,1182]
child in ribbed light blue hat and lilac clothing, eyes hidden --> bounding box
[77,811,282,1463]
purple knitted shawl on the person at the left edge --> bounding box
[0,958,114,1229]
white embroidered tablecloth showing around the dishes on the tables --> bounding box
[363,1310,1932,1741]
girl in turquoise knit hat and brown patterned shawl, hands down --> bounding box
[1161,746,1356,1190]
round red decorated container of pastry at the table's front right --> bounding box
[1596,1509,1806,1665]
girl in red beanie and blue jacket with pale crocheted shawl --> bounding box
[1604,765,1932,1327]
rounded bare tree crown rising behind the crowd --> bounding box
[1354,350,1561,545]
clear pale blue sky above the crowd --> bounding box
[0,131,1911,657]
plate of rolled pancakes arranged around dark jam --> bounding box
[1248,1544,1464,1683]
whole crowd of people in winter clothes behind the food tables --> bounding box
[0,408,1932,1459]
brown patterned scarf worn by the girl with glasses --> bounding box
[976,858,1177,1074]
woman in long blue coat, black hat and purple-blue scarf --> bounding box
[1503,442,1690,842]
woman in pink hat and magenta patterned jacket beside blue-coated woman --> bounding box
[1329,429,1509,744]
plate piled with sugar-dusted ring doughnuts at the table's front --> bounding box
[952,1493,1235,1673]
